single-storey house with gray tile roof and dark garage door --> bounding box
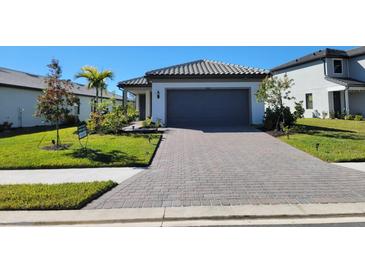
[118,60,269,127]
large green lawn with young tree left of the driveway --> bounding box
[0,127,160,169]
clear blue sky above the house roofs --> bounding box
[0,46,353,95]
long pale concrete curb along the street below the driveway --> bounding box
[0,203,365,226]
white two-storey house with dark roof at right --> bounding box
[271,47,365,118]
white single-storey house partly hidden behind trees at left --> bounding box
[0,67,122,127]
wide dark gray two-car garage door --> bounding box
[167,89,249,127]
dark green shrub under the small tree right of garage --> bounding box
[264,107,296,130]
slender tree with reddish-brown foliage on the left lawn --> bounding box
[35,59,79,149]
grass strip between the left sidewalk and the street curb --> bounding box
[0,181,117,210]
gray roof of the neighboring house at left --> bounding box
[0,67,122,99]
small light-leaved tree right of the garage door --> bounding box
[256,74,295,130]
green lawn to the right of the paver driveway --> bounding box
[279,118,365,162]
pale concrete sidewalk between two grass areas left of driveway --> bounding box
[0,167,146,185]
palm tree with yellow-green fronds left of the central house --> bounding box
[75,66,114,108]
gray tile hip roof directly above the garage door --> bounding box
[146,60,269,78]
